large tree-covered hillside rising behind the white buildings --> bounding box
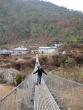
[0,0,83,45]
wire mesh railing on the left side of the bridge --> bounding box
[0,75,34,110]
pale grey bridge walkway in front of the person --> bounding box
[34,80,60,110]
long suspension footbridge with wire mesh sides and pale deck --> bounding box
[0,55,83,110]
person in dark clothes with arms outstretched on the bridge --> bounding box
[33,66,47,85]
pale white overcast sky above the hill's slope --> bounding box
[45,0,83,12]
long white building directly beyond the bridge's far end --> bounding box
[38,47,58,54]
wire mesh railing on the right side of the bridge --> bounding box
[44,74,83,110]
